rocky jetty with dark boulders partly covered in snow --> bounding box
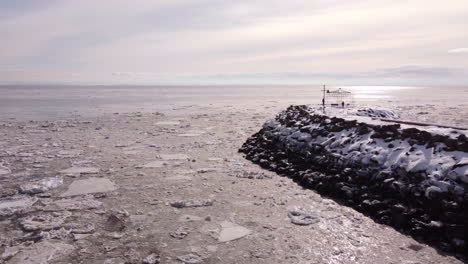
[240,105,468,256]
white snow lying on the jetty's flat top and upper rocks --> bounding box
[264,106,468,193]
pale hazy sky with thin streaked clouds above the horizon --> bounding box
[0,0,468,86]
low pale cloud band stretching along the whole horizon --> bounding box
[0,64,468,85]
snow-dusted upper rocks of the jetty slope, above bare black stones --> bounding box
[264,104,468,185]
